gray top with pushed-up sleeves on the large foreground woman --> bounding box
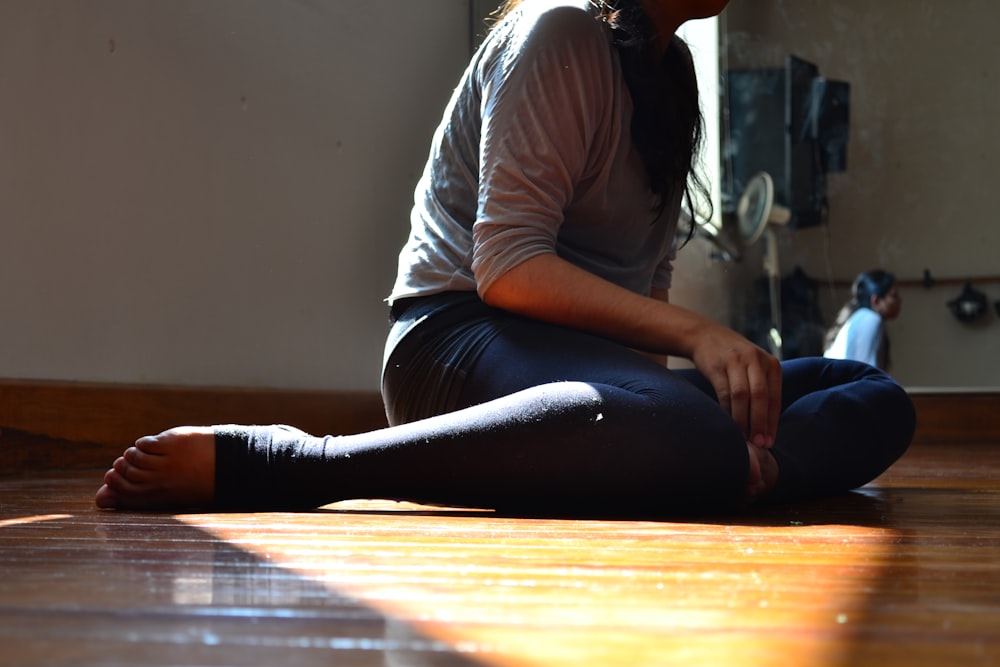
[389,0,679,303]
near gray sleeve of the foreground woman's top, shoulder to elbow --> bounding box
[472,7,615,293]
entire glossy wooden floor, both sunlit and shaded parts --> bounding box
[0,443,1000,667]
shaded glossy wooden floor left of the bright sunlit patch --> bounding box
[0,473,477,667]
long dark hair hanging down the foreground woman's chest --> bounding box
[496,0,712,238]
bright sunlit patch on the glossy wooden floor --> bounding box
[178,503,899,666]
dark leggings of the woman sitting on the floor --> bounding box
[216,295,915,516]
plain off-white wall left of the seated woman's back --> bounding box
[0,0,469,389]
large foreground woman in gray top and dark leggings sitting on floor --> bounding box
[96,0,915,516]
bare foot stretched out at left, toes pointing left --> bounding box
[94,426,215,509]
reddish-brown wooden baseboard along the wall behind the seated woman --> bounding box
[0,380,1000,474]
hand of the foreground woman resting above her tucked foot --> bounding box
[691,325,781,447]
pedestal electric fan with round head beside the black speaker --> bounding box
[736,171,792,360]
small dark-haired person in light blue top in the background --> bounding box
[823,269,903,370]
